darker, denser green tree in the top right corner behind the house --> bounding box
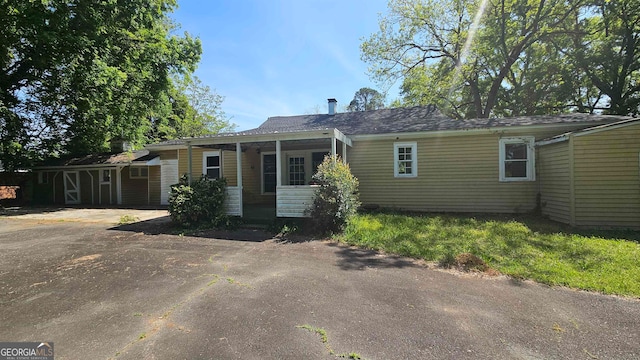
[565,0,640,115]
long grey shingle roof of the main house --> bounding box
[156,106,627,146]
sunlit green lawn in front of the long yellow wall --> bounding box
[337,213,640,297]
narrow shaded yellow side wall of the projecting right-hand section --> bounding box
[537,141,571,223]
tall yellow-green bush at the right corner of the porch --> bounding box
[309,156,360,233]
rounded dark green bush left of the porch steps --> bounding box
[169,174,229,227]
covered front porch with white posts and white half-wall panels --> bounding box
[178,129,352,217]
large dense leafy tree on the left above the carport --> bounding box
[0,0,201,169]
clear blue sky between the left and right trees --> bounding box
[172,0,398,130]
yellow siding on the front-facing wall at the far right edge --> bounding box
[574,124,640,228]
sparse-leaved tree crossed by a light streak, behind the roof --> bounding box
[361,0,585,118]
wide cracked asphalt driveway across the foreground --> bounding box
[0,217,640,359]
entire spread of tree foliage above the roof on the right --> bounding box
[361,0,640,118]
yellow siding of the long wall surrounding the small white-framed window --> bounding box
[348,134,538,212]
